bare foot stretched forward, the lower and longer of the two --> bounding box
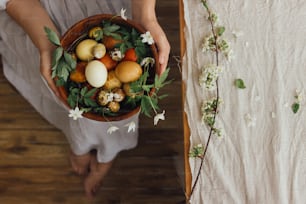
[84,154,113,199]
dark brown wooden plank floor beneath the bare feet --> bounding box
[0,0,185,204]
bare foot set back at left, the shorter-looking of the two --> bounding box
[70,151,91,175]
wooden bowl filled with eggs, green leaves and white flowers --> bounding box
[45,14,170,125]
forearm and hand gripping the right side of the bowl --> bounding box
[132,0,170,75]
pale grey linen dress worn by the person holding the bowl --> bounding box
[0,0,139,162]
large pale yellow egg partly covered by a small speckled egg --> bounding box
[75,39,98,61]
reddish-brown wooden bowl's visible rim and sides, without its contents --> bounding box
[58,14,159,122]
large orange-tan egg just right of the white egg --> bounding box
[115,61,142,83]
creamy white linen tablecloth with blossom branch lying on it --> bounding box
[183,0,306,204]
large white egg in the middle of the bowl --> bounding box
[85,60,107,88]
